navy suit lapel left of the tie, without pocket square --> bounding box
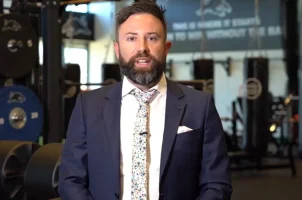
[103,83,122,187]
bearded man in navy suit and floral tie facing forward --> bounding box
[59,2,232,200]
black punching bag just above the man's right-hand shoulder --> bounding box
[193,59,214,94]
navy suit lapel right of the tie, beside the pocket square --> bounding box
[160,79,186,180]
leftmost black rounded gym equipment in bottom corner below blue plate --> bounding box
[0,141,40,200]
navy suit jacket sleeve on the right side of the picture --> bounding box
[197,95,232,200]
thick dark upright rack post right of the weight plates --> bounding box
[41,0,64,144]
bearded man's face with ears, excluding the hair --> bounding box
[114,14,171,86]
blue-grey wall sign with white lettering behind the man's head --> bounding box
[157,0,282,53]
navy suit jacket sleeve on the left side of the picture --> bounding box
[58,94,92,200]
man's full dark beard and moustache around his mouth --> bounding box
[119,53,166,86]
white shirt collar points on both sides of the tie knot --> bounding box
[122,73,167,97]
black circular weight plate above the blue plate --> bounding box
[0,14,39,78]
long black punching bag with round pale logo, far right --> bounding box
[243,58,270,156]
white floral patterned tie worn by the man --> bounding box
[130,89,156,200]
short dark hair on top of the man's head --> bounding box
[116,0,167,41]
